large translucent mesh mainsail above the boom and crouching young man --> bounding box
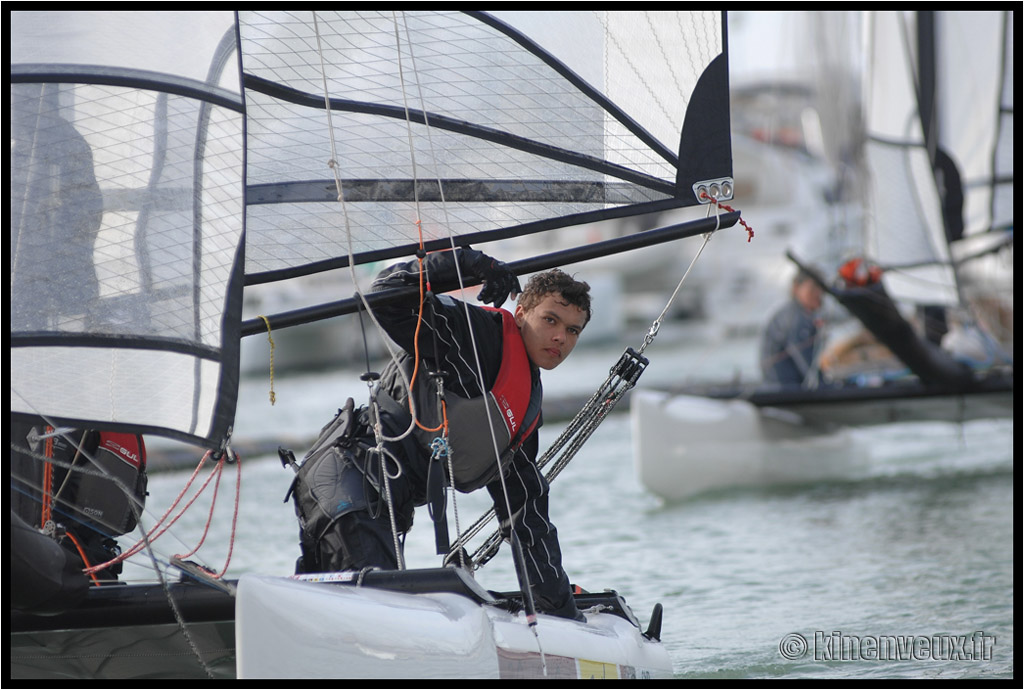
[239,11,731,279]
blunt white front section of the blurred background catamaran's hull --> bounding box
[630,390,869,501]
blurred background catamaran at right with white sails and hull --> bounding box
[631,11,1015,499]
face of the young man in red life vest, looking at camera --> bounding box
[515,293,587,370]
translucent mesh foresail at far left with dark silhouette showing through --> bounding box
[9,12,245,445]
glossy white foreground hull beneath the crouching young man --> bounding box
[236,575,672,679]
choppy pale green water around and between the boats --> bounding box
[138,335,1016,679]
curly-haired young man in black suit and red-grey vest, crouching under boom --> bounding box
[296,248,591,619]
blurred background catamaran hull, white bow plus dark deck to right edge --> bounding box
[630,374,1014,501]
